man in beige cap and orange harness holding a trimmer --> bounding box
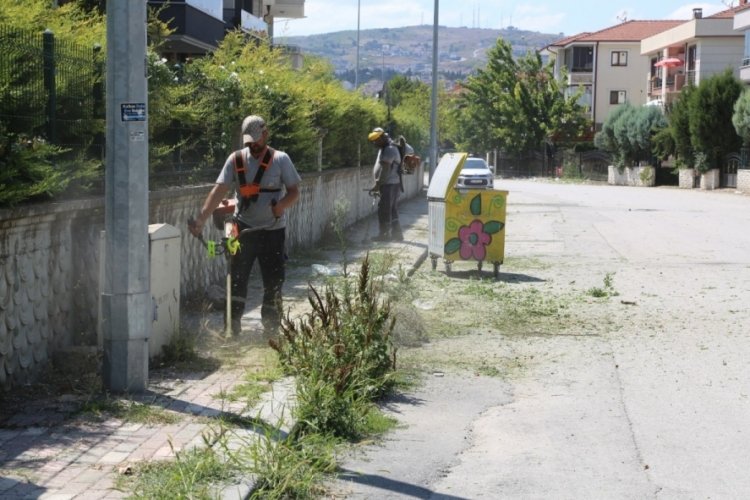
[190,116,301,335]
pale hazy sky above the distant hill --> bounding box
[274,0,738,37]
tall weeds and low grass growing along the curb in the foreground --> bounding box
[118,256,401,499]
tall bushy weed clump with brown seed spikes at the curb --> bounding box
[271,258,396,437]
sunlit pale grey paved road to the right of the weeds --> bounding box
[332,180,750,499]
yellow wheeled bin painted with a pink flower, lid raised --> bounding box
[427,153,508,278]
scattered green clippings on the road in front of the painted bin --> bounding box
[399,258,618,378]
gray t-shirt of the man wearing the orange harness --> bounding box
[216,148,302,229]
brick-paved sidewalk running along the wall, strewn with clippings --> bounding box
[0,193,428,500]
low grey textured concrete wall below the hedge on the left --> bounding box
[0,167,424,389]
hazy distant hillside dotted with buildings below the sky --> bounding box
[276,24,563,81]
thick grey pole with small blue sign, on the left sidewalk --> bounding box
[102,0,153,392]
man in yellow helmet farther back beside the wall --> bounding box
[367,127,404,241]
